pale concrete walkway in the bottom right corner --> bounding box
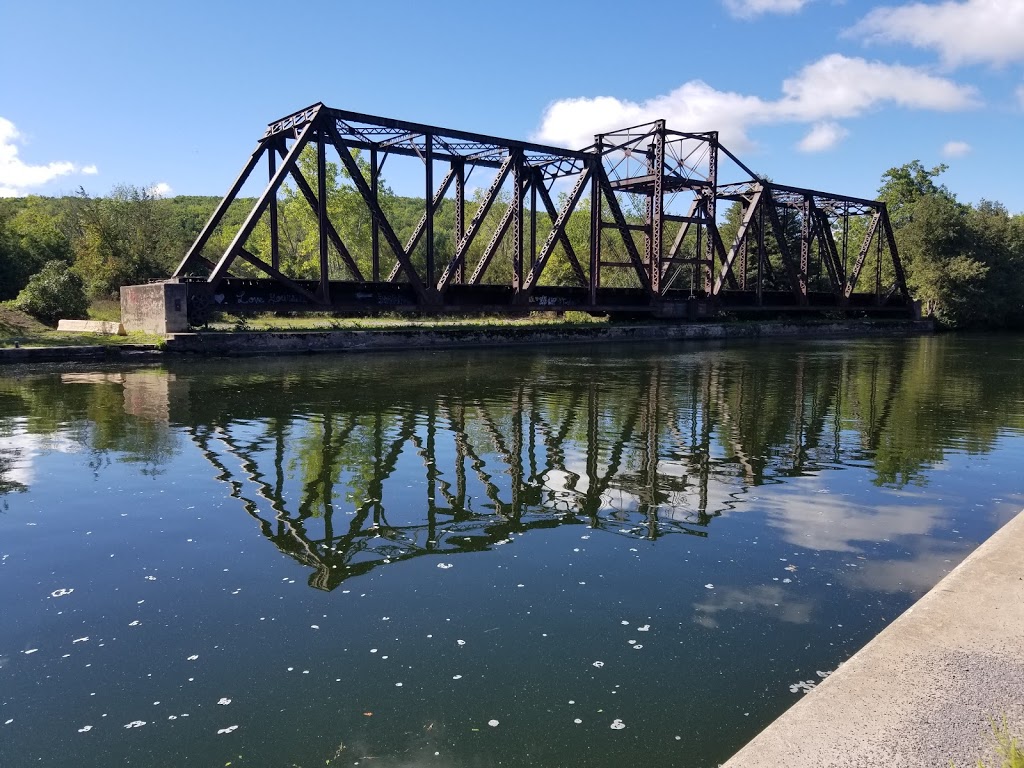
[725,513,1024,768]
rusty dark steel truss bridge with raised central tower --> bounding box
[173,103,912,323]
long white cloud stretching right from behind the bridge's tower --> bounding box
[536,54,977,150]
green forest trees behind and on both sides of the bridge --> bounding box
[0,155,1024,329]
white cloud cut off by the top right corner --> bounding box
[848,0,1024,65]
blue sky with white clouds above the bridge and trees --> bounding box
[0,0,1024,213]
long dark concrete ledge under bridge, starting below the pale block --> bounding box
[161,321,934,355]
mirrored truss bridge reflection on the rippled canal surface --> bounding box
[176,347,903,590]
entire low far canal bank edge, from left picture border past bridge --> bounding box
[0,321,934,364]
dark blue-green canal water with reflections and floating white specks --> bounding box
[0,336,1024,768]
